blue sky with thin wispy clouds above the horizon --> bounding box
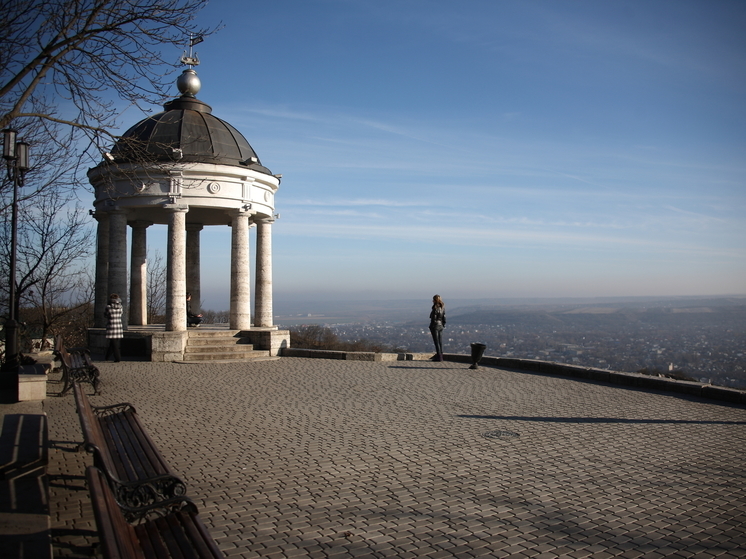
[110,0,746,309]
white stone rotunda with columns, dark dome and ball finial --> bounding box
[88,67,281,360]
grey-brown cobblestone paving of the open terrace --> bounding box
[44,358,746,559]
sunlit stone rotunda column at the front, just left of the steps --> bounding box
[163,204,189,332]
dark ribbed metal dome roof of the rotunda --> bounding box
[111,95,272,175]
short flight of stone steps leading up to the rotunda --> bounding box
[184,328,270,362]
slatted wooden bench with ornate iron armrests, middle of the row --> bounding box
[73,383,186,520]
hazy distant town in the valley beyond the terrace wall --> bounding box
[278,297,746,388]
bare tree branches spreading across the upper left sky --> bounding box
[0,0,212,170]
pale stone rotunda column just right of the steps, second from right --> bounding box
[230,210,251,330]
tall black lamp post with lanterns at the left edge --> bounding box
[2,128,29,382]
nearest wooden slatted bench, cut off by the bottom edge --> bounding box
[86,466,224,559]
